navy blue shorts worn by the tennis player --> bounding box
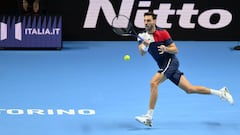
[158,59,183,85]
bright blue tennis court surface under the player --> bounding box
[0,41,240,135]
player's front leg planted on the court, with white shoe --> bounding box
[136,72,166,126]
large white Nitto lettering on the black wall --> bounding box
[83,0,232,29]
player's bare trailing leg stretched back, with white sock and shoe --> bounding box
[178,75,234,104]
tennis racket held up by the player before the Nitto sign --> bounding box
[112,15,144,41]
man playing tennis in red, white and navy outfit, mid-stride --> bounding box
[136,12,234,126]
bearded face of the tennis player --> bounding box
[144,15,156,33]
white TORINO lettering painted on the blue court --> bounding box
[0,108,96,116]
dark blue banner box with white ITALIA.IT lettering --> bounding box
[0,16,62,49]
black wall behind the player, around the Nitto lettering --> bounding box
[0,0,240,41]
